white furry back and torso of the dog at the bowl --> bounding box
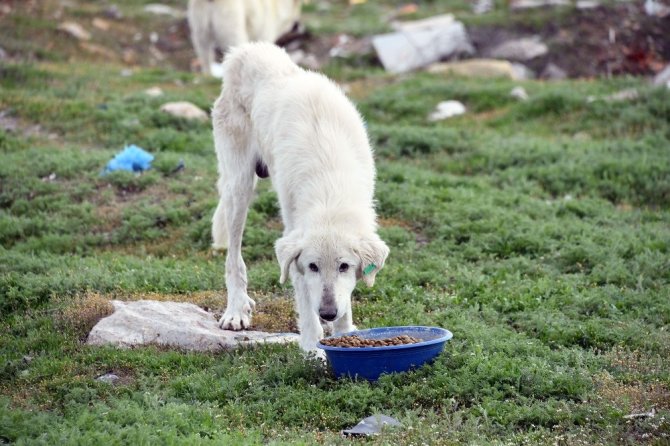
[217,43,375,233]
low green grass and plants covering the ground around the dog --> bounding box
[0,1,670,445]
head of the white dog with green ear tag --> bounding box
[275,231,389,321]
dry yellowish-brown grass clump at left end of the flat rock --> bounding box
[54,293,114,339]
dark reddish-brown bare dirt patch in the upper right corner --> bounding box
[468,2,670,77]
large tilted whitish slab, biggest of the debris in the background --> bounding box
[372,14,474,73]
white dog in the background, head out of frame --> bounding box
[188,0,302,73]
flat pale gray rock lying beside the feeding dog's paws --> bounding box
[86,300,298,351]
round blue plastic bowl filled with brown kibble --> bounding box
[316,326,453,381]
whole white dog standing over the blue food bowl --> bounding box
[212,43,389,351]
